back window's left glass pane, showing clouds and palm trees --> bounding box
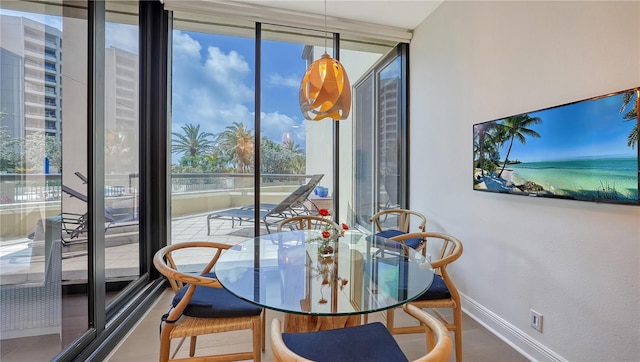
[171,12,255,244]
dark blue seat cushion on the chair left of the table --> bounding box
[172,273,262,318]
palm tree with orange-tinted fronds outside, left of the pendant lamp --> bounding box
[216,122,254,172]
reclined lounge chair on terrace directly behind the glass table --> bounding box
[207,175,323,235]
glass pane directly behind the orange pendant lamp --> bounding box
[260,25,333,222]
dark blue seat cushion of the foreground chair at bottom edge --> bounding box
[282,322,408,362]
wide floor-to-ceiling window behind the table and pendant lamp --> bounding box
[166,11,395,243]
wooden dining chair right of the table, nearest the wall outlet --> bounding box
[387,232,462,362]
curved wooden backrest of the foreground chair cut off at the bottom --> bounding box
[271,304,453,362]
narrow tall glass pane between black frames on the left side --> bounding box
[104,1,140,306]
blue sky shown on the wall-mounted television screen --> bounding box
[490,94,638,162]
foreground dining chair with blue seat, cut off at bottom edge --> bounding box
[271,304,452,362]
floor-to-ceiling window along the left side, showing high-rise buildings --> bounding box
[0,1,161,361]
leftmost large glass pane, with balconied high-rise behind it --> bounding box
[0,1,88,360]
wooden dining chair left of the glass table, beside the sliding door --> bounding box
[153,241,265,362]
